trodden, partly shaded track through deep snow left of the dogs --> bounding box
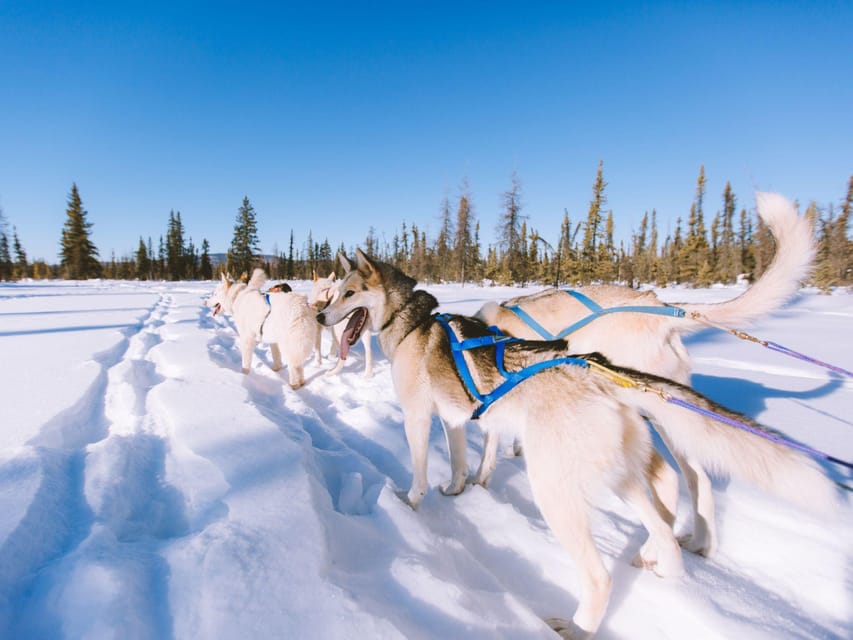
[0,294,188,638]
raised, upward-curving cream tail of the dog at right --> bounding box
[678,192,816,331]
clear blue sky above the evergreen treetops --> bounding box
[0,0,853,262]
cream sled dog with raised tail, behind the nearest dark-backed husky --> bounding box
[474,193,815,556]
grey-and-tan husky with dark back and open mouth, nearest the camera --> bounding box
[317,251,837,637]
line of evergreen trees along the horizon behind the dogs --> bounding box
[0,169,853,289]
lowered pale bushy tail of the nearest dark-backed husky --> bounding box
[633,378,842,514]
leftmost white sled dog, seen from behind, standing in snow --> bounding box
[205,269,320,389]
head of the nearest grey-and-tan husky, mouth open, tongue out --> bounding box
[317,249,386,344]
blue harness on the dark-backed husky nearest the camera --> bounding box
[435,313,589,420]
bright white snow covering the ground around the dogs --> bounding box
[0,281,853,640]
